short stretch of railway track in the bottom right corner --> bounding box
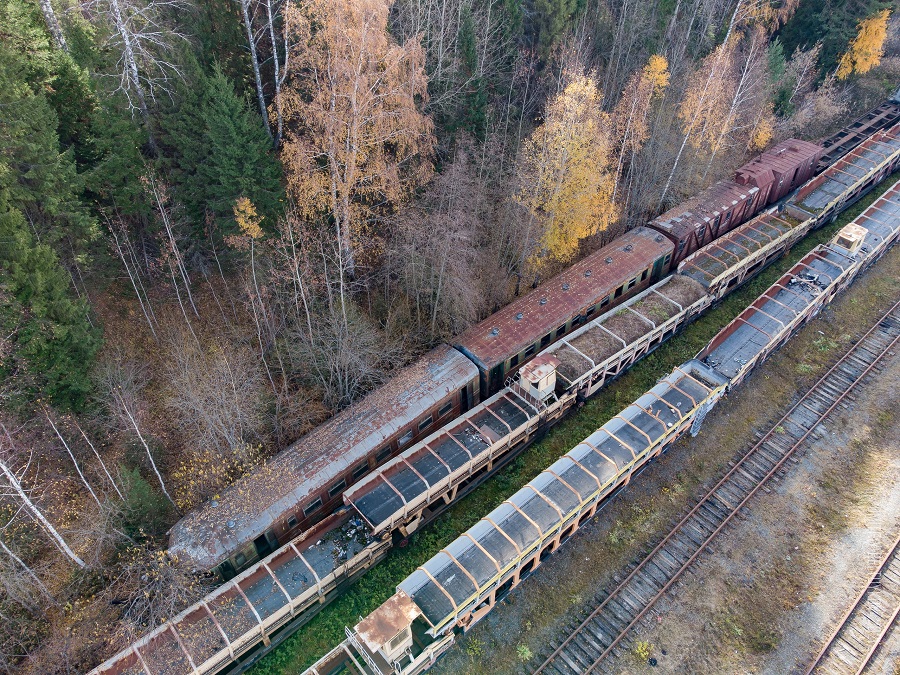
[805,537,900,675]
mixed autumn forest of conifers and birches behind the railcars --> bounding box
[0,0,900,674]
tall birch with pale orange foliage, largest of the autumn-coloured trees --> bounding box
[282,0,434,280]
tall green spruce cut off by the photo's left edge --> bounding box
[0,44,100,409]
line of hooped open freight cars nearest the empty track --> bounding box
[306,182,900,675]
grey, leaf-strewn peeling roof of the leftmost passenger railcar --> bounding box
[169,345,478,569]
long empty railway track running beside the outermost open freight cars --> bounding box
[533,302,900,675]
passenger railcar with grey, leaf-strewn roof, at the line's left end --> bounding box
[169,345,479,579]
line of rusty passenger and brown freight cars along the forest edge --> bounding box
[169,116,890,579]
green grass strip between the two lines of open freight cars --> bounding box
[250,172,900,675]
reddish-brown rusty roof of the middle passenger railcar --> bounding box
[456,227,674,370]
